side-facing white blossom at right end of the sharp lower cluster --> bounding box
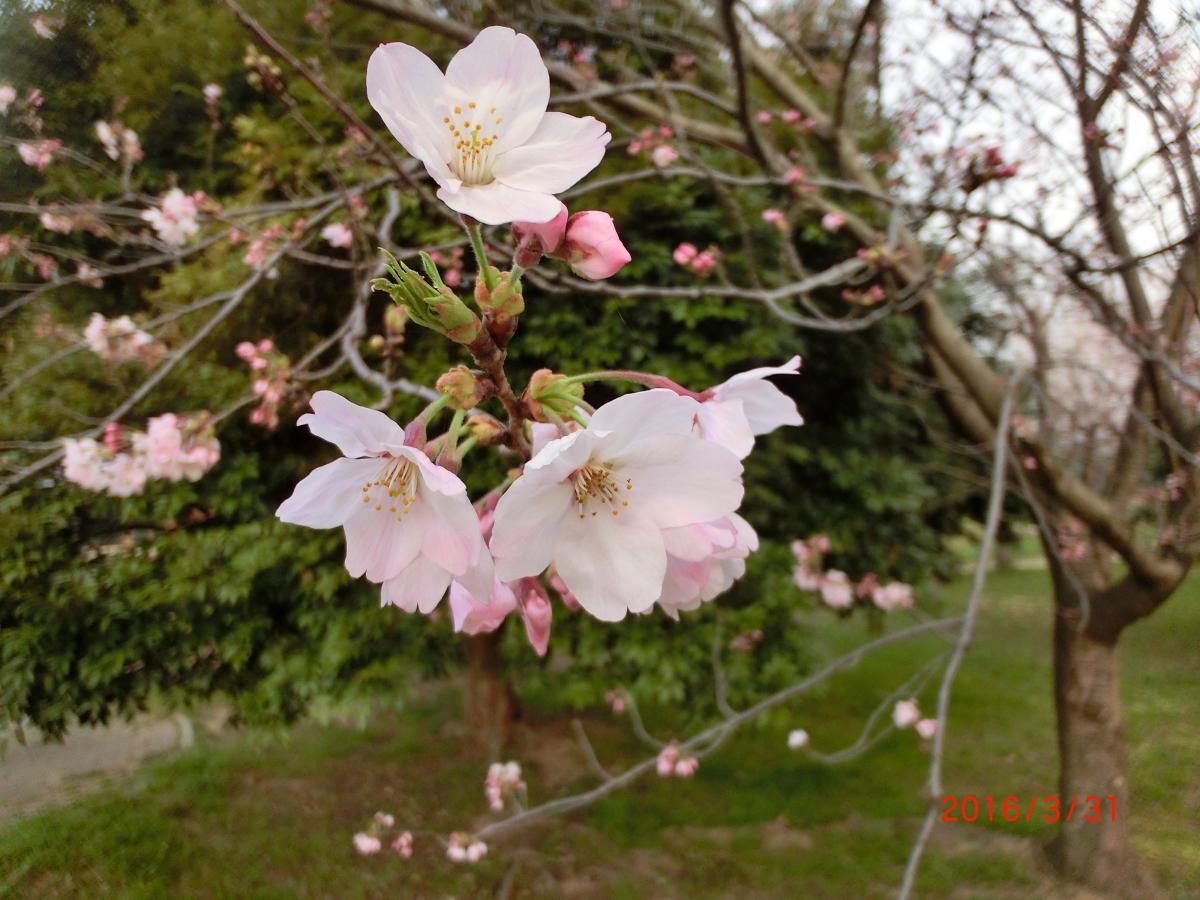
[696,356,804,460]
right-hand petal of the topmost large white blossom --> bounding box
[492,113,612,193]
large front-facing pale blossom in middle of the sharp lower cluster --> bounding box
[491,389,743,622]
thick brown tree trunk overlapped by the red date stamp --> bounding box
[1050,604,1157,898]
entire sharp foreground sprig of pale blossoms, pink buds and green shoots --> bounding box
[277,28,803,648]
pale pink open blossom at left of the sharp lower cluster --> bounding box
[276,391,492,613]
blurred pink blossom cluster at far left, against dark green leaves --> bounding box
[62,413,221,497]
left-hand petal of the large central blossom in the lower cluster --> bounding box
[490,475,575,581]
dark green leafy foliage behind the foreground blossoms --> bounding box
[0,0,974,733]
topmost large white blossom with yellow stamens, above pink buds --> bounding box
[367,26,611,224]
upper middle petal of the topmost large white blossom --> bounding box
[445,25,553,153]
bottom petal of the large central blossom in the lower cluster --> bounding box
[554,506,667,622]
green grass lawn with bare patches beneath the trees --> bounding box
[0,571,1200,899]
